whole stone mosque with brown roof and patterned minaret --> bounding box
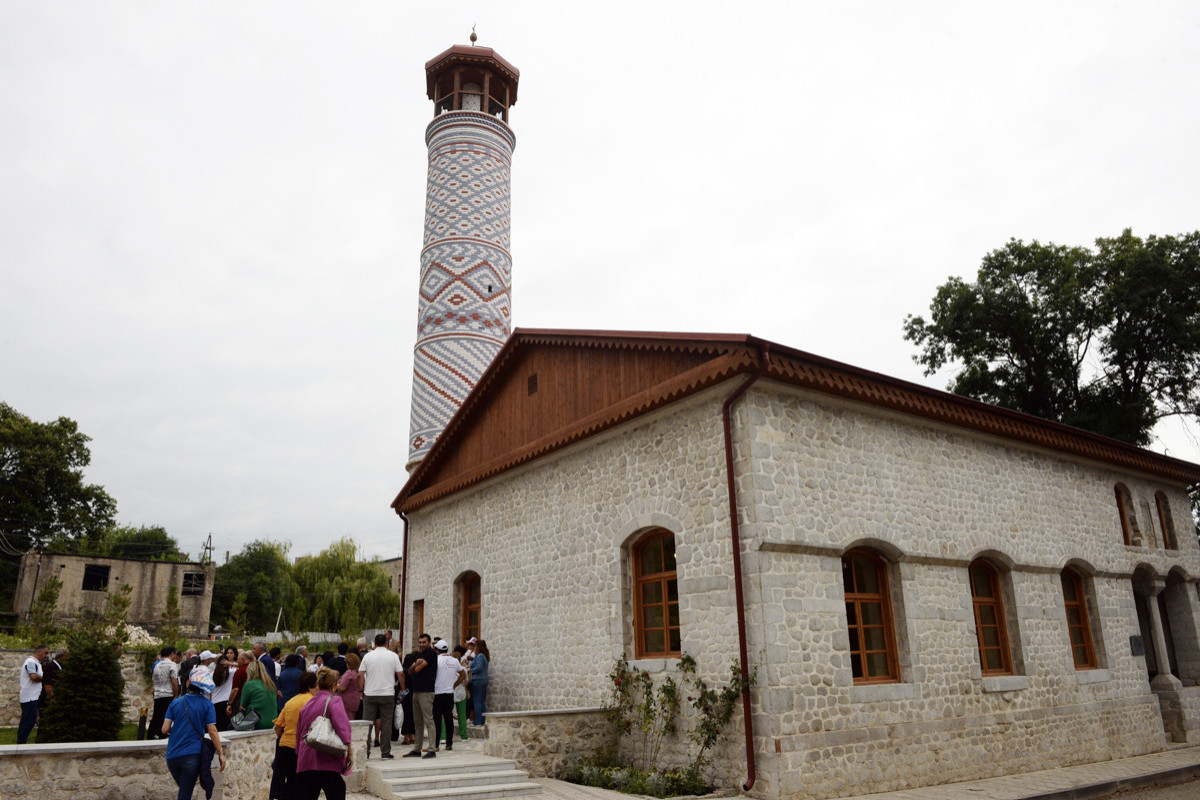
[392,40,1200,799]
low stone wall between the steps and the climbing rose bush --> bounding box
[484,709,612,778]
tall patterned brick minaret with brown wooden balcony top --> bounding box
[407,40,521,471]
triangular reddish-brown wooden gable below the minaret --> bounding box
[394,329,754,510]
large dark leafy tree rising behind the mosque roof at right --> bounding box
[905,229,1200,445]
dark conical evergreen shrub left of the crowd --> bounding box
[37,584,130,744]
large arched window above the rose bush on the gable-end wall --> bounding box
[631,529,680,658]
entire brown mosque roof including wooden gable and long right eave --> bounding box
[392,327,1200,512]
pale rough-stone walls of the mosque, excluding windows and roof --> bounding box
[406,383,1200,798]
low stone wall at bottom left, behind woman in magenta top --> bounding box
[0,722,368,800]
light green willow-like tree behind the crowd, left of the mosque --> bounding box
[290,537,400,636]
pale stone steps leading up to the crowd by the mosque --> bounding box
[366,751,541,800]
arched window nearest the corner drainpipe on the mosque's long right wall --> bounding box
[841,551,900,684]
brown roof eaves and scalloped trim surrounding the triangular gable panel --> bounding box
[392,327,1200,512]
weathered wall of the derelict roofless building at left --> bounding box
[13,553,216,636]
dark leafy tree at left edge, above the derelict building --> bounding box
[0,403,116,608]
